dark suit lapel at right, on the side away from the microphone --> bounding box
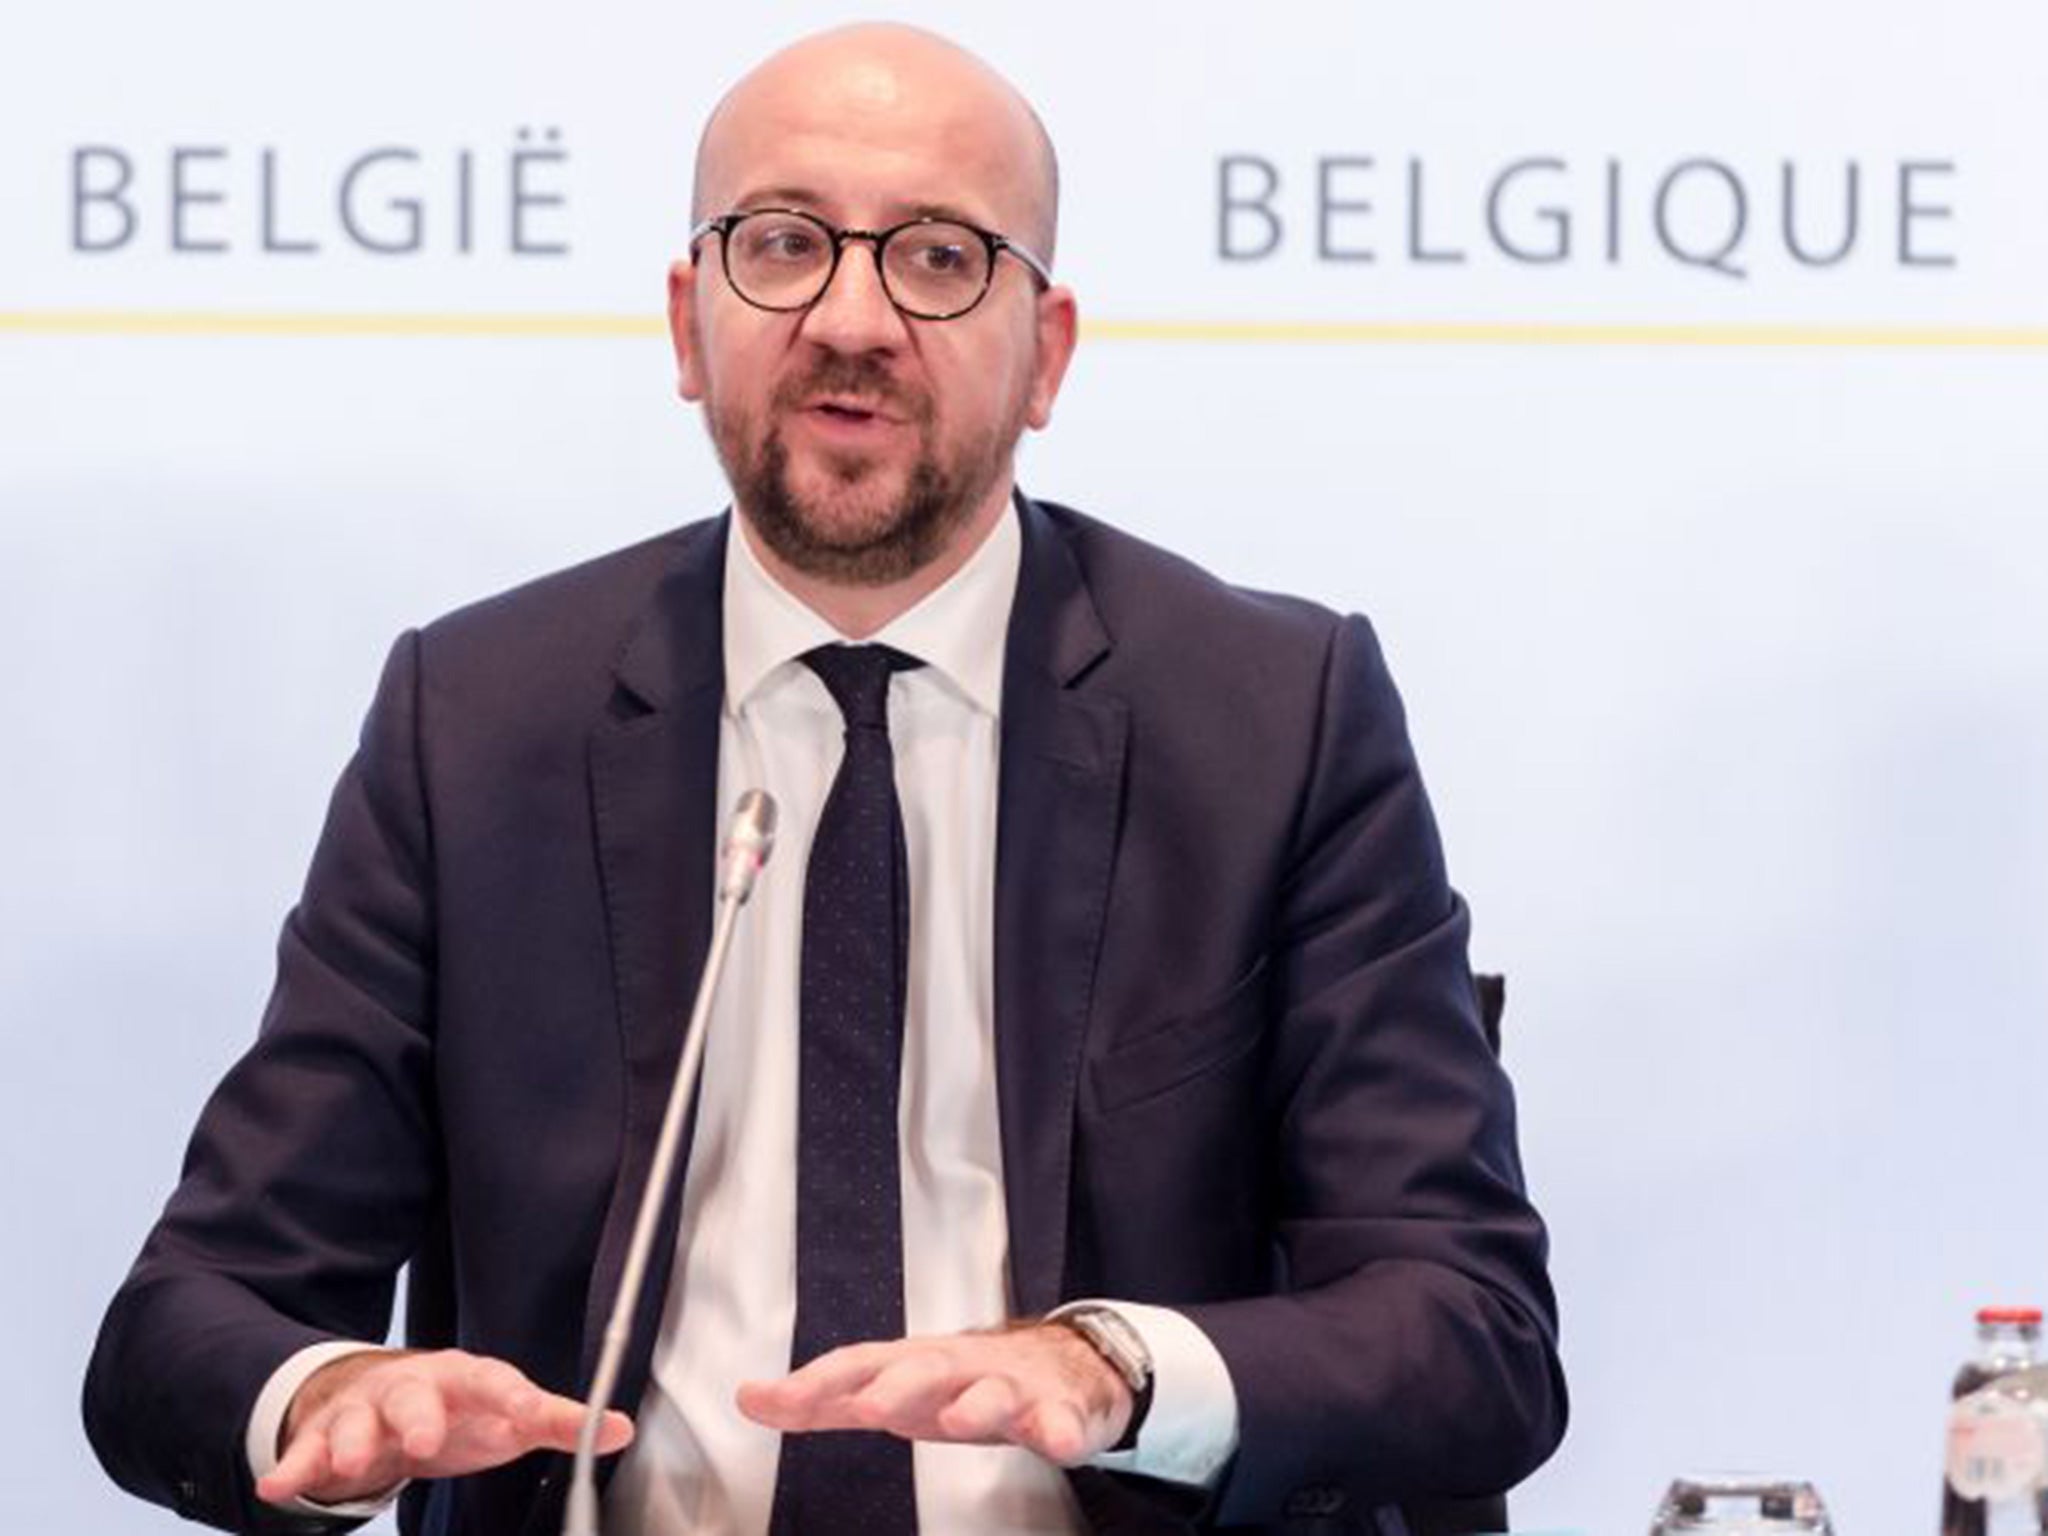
[995,496,1126,1313]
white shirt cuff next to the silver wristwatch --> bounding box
[1053,1298,1237,1487]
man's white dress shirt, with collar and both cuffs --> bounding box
[248,512,1237,1536]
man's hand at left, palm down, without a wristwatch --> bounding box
[256,1350,633,1503]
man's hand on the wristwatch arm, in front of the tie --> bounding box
[739,1323,1130,1466]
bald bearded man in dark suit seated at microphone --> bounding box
[86,27,1565,1536]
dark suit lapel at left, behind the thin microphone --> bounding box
[578,520,727,1409]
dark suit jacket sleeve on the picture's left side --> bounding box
[84,635,438,1532]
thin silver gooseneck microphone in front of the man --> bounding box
[561,788,774,1536]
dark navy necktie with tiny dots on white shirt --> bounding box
[770,645,918,1536]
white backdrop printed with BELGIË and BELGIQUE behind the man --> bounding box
[0,0,2048,1536]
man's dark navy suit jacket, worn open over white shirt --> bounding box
[86,498,1565,1536]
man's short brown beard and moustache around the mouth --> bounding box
[705,352,1024,586]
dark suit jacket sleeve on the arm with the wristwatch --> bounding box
[1184,618,1565,1524]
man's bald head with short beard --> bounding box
[670,25,1075,602]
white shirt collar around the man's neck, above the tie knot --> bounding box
[725,504,1024,717]
